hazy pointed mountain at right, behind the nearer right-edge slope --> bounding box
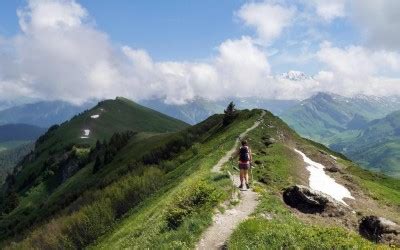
[281,93,400,145]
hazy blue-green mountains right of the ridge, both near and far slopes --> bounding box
[281,93,400,176]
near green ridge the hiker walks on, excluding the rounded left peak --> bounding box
[1,110,400,249]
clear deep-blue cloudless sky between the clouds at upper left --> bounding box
[0,0,249,60]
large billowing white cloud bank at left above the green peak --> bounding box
[0,0,278,103]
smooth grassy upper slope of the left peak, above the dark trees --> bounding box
[11,98,188,191]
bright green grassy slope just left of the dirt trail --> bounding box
[93,111,260,249]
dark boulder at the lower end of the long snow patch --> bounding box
[283,185,348,217]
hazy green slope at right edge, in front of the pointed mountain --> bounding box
[331,111,400,177]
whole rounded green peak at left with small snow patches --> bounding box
[0,98,188,242]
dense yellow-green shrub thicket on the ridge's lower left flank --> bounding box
[10,167,165,249]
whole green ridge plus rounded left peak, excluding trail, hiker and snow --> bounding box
[0,98,400,249]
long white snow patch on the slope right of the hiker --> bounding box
[294,149,354,205]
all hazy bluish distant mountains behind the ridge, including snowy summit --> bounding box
[0,91,400,175]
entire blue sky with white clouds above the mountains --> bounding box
[0,0,400,104]
